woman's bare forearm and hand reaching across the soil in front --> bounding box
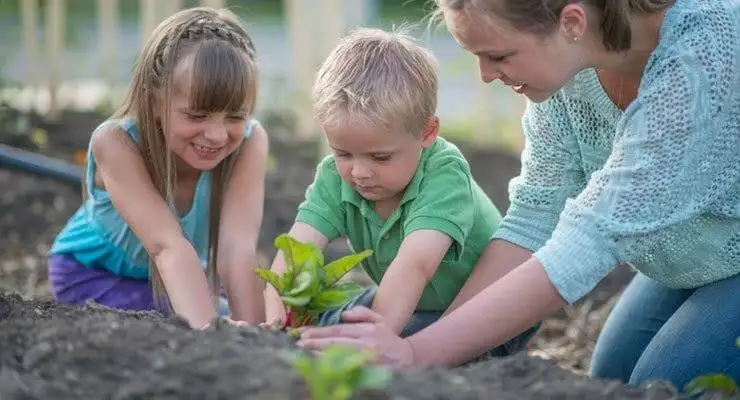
[298,258,565,368]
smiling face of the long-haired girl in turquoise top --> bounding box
[160,66,248,171]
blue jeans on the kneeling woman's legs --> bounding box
[590,274,740,391]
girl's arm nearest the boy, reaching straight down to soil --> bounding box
[217,124,269,324]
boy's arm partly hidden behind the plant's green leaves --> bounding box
[264,221,329,324]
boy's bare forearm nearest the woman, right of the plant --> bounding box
[373,229,452,334]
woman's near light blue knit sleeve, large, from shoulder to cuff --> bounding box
[535,23,740,302]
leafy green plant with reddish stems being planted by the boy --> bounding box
[255,234,372,333]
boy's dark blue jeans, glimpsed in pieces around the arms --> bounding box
[318,287,541,359]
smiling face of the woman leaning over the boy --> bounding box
[444,9,584,102]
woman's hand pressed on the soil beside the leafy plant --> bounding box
[298,306,414,368]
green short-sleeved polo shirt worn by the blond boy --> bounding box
[296,138,501,311]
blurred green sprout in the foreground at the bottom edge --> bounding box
[284,346,392,400]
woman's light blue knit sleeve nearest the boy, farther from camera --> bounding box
[493,93,585,252]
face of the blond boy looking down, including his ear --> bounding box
[324,117,439,202]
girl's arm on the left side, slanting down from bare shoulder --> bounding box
[91,125,218,328]
